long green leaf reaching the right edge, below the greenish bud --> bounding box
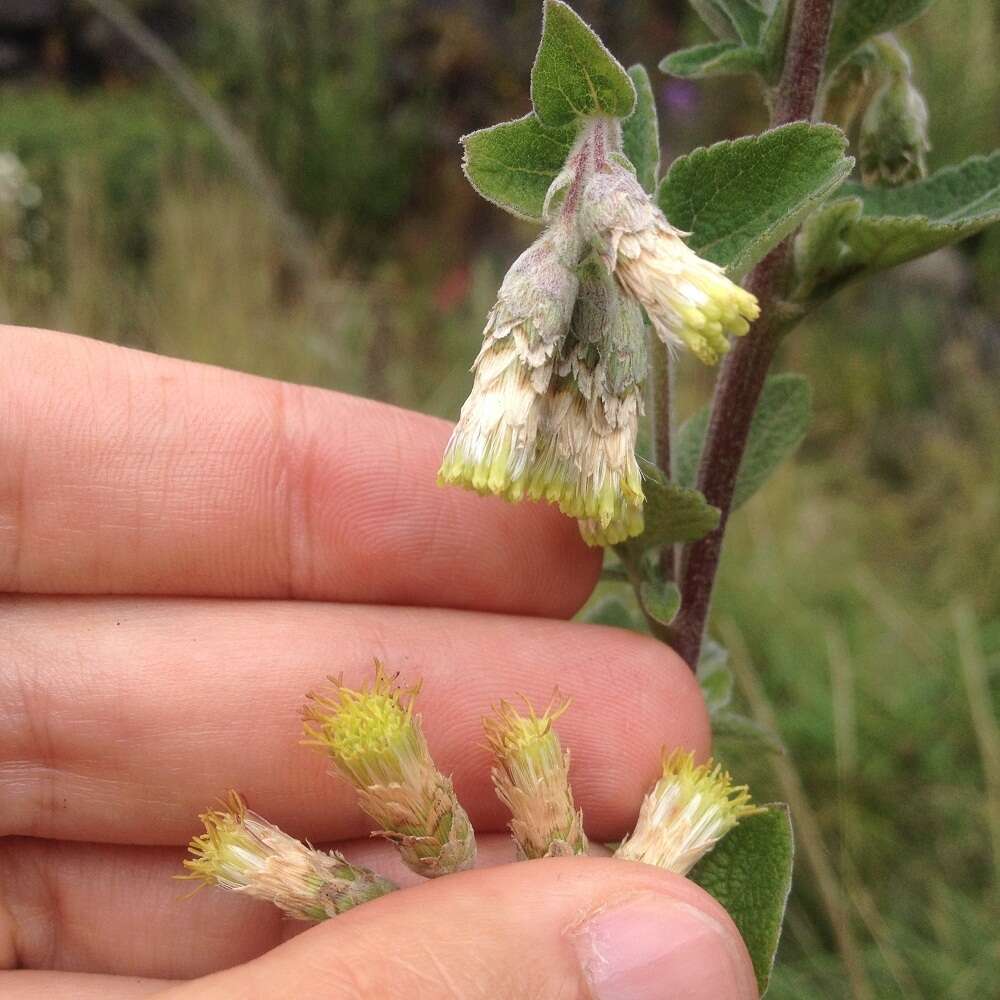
[831,150,1000,273]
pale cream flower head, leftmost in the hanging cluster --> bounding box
[438,225,579,501]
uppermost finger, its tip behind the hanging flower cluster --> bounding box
[0,327,600,616]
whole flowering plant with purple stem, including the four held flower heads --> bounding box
[182,0,1000,993]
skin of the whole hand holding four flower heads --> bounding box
[0,327,756,1000]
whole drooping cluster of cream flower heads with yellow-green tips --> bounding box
[439,120,758,545]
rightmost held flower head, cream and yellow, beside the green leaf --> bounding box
[615,750,761,875]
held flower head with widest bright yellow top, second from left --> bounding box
[305,663,476,878]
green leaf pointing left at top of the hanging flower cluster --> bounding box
[462,114,576,222]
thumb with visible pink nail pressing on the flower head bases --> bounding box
[165,858,757,1000]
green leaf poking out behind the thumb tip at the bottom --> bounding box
[689,803,795,996]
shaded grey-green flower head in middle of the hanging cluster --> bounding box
[528,270,646,545]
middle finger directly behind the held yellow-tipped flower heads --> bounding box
[0,598,710,844]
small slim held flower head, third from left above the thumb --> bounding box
[483,701,587,859]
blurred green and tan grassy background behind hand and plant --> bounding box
[0,0,1000,1000]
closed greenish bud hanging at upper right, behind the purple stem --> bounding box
[858,74,930,187]
